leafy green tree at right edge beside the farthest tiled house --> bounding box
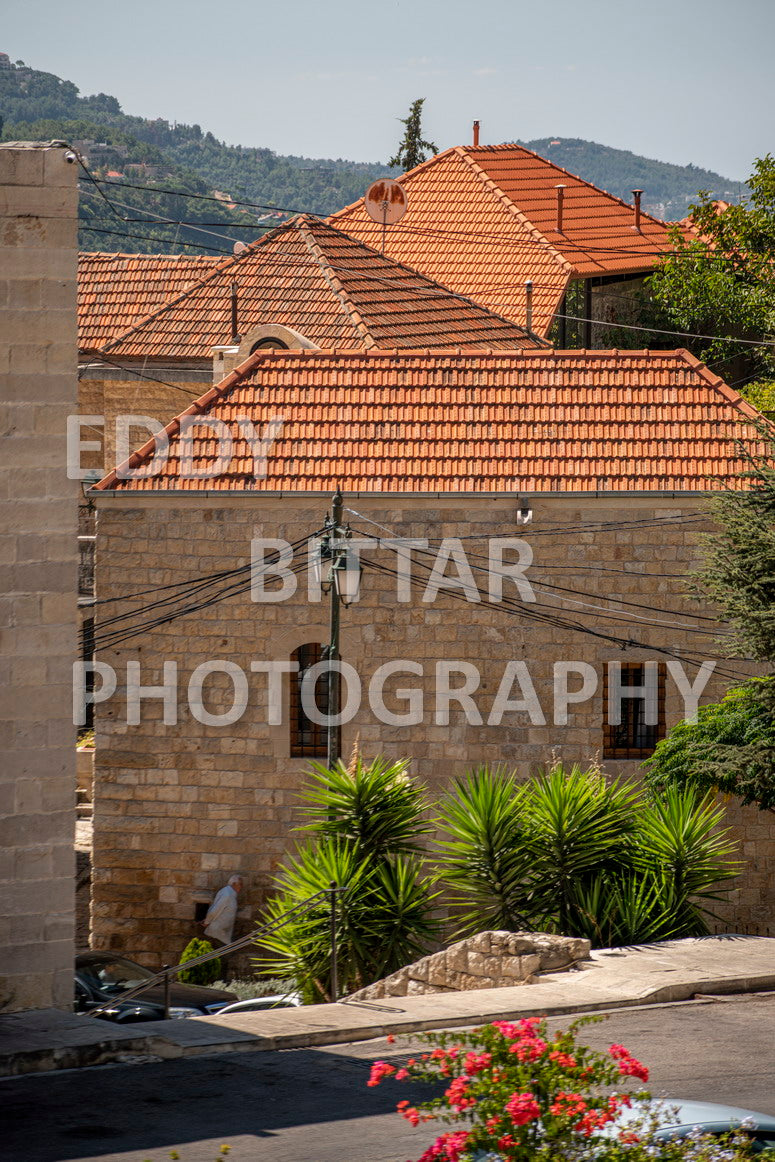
[648,155,775,380]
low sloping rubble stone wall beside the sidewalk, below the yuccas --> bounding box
[347,932,589,1000]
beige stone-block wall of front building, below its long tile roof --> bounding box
[87,494,773,963]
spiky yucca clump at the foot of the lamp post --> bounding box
[257,755,438,1002]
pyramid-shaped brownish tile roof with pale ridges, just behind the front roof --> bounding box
[83,215,540,360]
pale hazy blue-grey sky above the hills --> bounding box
[0,0,775,179]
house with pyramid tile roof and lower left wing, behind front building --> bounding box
[79,215,546,467]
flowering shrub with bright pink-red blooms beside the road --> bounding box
[367,1017,771,1162]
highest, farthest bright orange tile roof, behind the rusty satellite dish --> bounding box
[331,144,672,335]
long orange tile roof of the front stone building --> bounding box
[96,351,758,493]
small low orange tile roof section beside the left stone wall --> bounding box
[78,253,223,353]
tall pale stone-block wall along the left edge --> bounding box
[0,143,78,1011]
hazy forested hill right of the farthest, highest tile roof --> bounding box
[522,137,753,221]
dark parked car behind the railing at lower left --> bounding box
[76,952,237,1025]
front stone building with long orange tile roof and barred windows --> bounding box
[92,351,775,962]
